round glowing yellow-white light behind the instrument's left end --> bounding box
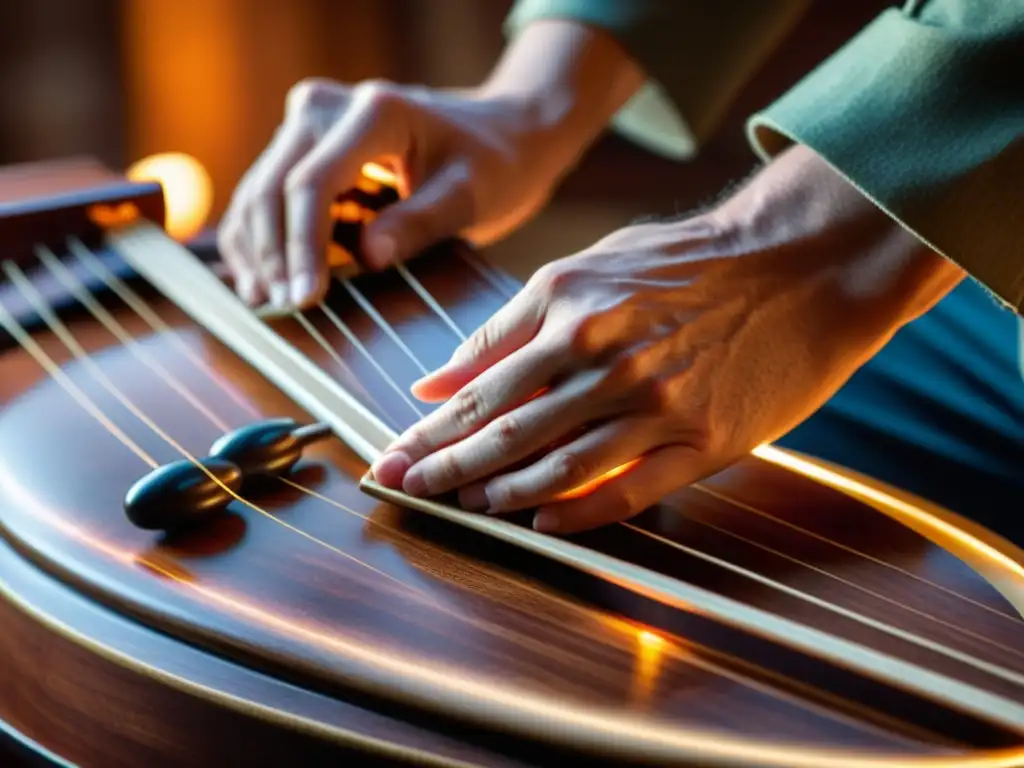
[126,153,213,241]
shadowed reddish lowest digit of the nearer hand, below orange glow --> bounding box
[534,444,708,534]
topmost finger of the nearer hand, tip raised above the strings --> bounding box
[412,288,544,402]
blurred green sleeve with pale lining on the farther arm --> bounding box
[506,0,810,160]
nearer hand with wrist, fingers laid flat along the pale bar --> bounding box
[372,147,963,532]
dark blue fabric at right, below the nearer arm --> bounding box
[777,280,1024,546]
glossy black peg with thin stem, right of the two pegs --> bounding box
[210,419,331,480]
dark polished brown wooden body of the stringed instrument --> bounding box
[0,159,1024,766]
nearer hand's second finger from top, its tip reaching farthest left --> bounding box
[372,337,561,486]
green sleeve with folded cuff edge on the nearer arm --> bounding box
[749,0,1024,312]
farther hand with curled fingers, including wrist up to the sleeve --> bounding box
[218,20,643,308]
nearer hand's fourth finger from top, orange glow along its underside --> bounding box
[460,418,660,513]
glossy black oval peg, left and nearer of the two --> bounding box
[124,458,244,530]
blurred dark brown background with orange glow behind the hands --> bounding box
[0,0,892,276]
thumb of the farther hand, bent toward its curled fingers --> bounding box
[362,162,475,269]
